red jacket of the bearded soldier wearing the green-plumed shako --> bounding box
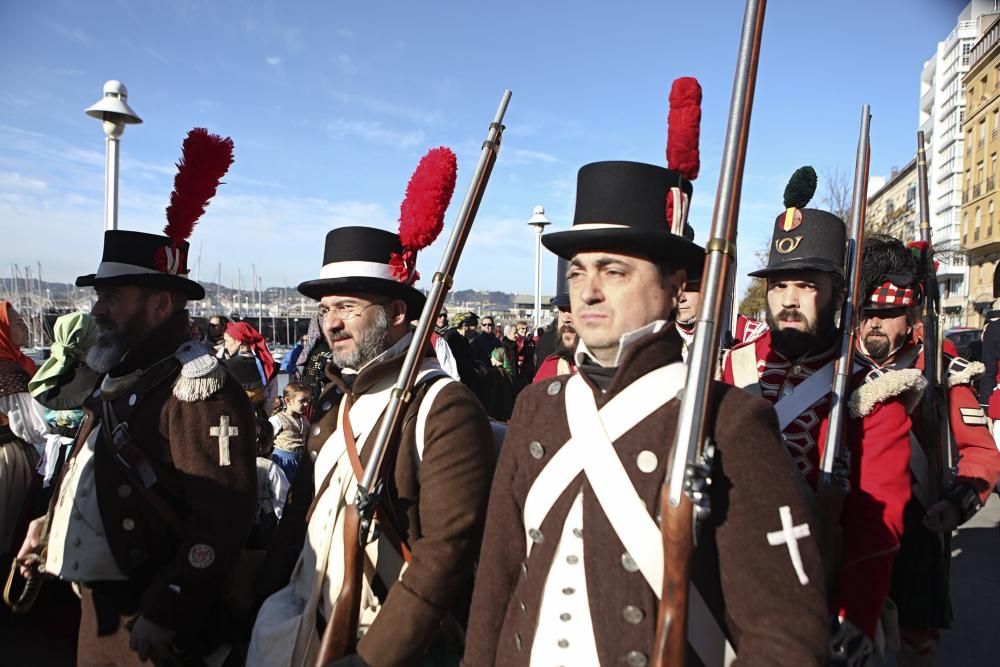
[723,331,922,637]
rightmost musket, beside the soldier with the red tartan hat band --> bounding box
[917,130,957,496]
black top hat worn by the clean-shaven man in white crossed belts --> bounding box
[542,162,705,277]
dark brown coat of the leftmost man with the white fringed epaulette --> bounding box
[53,312,257,632]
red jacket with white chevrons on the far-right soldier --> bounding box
[858,341,1000,509]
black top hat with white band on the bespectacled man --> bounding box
[299,227,426,320]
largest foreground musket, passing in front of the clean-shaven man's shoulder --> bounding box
[652,0,767,667]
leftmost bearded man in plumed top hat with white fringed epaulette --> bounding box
[21,129,257,665]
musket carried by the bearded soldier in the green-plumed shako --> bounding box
[817,104,871,590]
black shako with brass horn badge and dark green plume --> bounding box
[748,167,847,278]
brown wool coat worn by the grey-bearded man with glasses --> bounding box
[261,344,495,667]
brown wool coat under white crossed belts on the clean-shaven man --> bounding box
[464,327,828,667]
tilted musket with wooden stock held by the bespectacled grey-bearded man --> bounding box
[316,90,511,667]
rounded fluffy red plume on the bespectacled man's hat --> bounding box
[389,146,458,285]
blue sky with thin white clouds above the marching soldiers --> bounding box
[0,0,965,292]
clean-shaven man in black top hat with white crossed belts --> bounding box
[465,162,826,667]
